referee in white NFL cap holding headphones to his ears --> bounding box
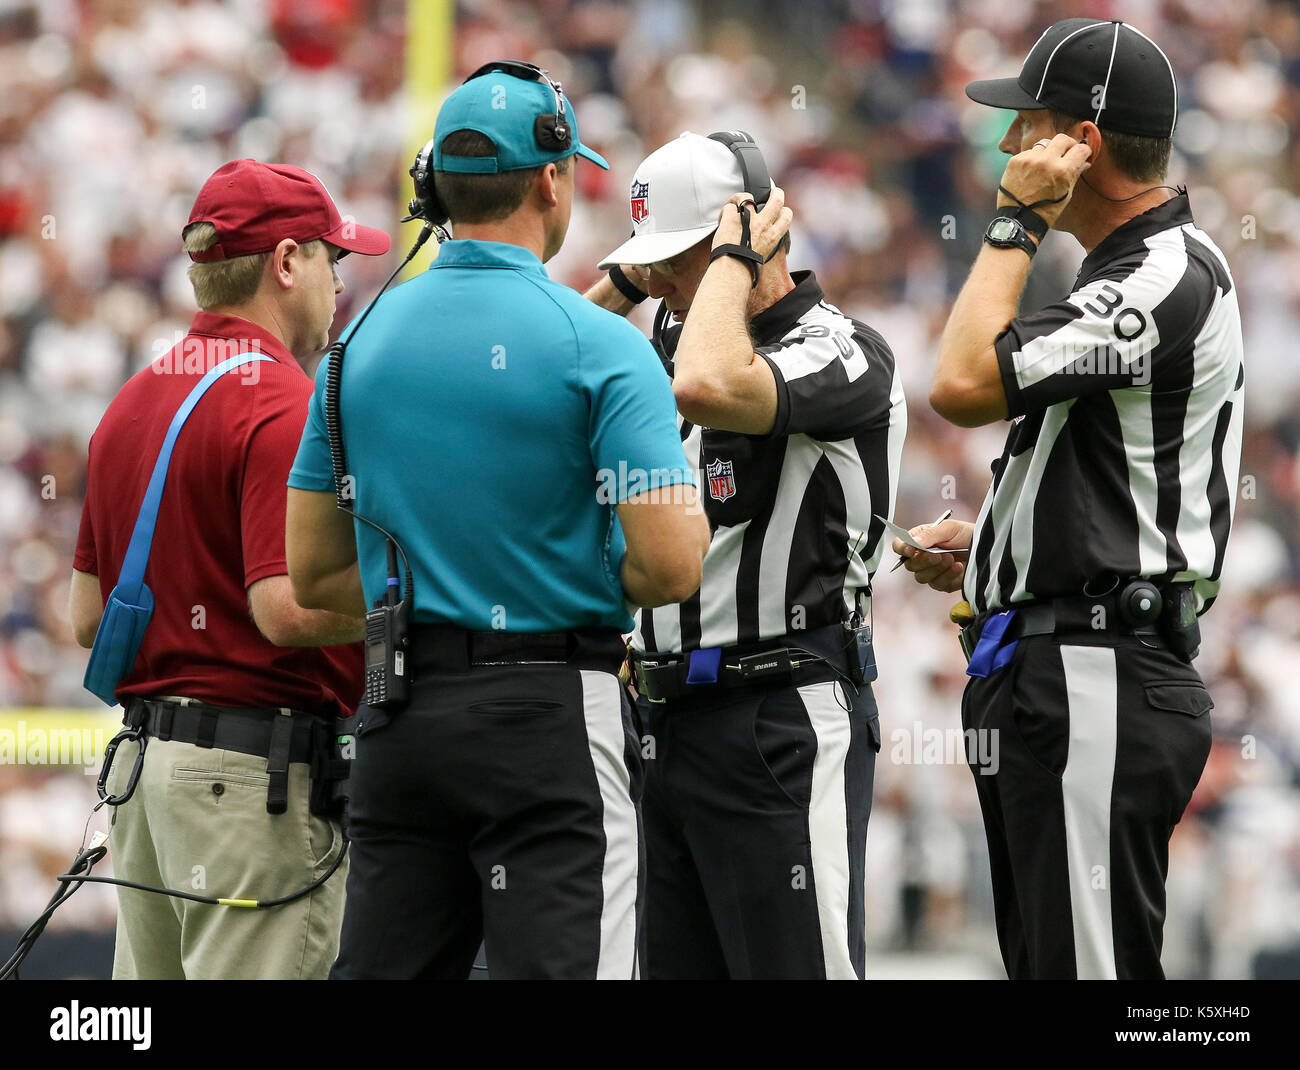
[588,131,906,979]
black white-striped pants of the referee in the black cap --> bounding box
[962,634,1213,979]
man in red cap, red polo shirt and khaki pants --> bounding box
[70,160,389,979]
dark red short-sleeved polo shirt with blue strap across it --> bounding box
[74,312,361,715]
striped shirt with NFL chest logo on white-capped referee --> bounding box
[632,272,907,651]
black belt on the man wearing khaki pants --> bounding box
[122,698,327,814]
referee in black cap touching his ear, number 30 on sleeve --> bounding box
[894,18,1244,978]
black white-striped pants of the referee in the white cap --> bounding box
[637,673,880,979]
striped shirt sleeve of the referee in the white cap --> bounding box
[758,316,894,439]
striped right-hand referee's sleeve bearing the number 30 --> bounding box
[993,230,1206,416]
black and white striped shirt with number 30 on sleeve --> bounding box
[963,192,1245,611]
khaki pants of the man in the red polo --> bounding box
[108,738,347,980]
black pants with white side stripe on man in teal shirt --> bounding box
[332,664,644,979]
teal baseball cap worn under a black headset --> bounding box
[433,60,610,174]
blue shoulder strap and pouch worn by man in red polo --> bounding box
[82,352,270,706]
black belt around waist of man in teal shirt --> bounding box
[411,624,627,679]
